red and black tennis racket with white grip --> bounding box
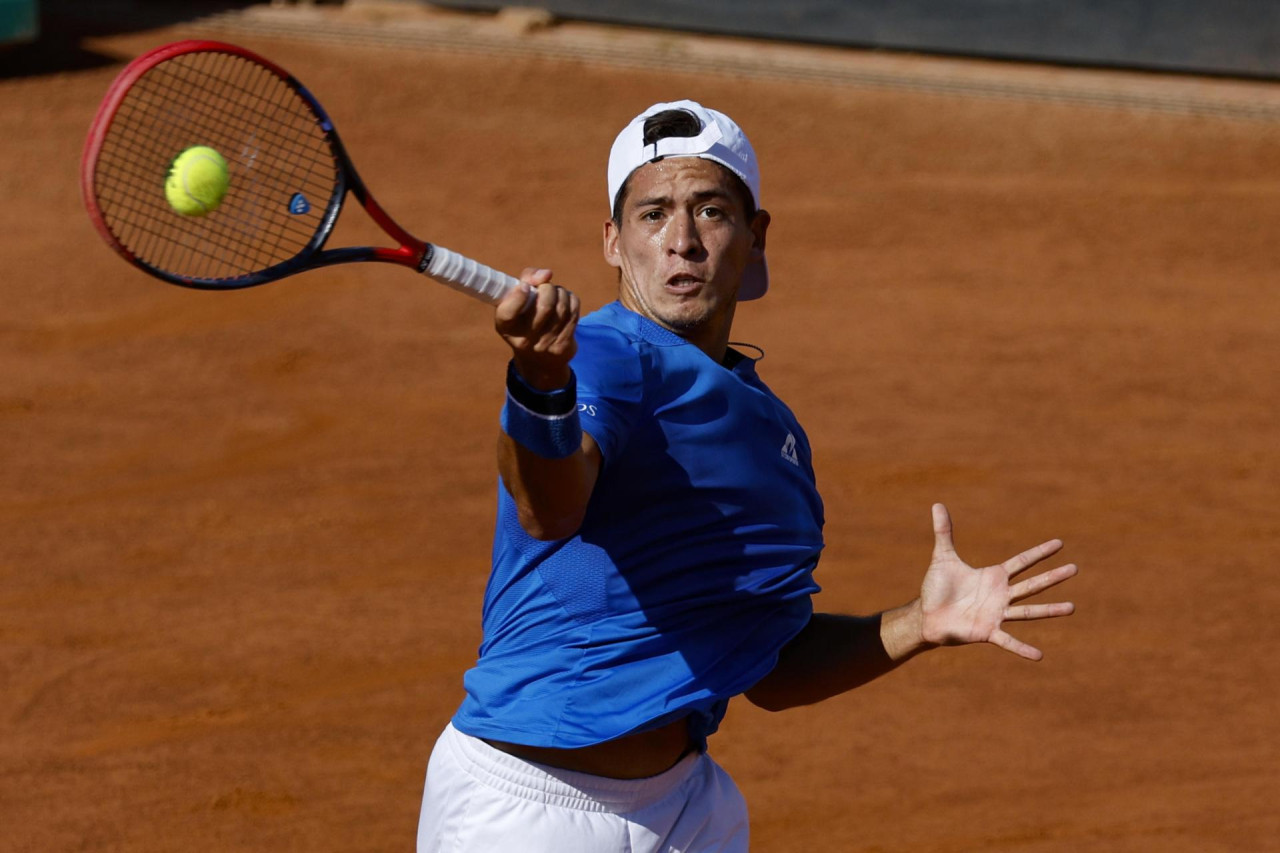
[81,41,520,302]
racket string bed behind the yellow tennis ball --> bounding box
[95,51,338,280]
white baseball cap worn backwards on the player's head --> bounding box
[609,100,769,301]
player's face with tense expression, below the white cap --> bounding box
[604,158,769,357]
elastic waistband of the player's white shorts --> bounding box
[440,722,708,815]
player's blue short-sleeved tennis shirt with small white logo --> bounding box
[453,302,823,748]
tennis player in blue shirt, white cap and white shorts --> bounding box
[417,101,1075,853]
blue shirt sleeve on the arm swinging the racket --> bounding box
[572,324,644,465]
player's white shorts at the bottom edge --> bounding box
[417,724,748,853]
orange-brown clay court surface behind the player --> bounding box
[0,8,1280,853]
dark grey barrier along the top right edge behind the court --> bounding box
[433,0,1280,78]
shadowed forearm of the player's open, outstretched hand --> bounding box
[746,601,929,711]
